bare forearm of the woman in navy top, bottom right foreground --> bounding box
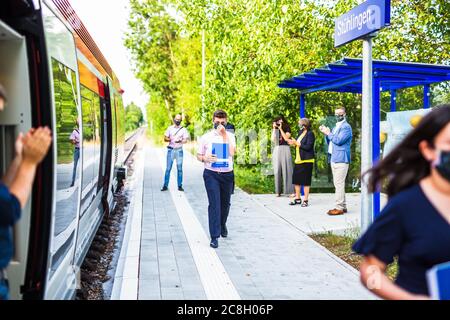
[360,255,429,300]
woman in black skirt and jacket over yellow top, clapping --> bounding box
[288,118,316,207]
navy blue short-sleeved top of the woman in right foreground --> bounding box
[353,185,450,295]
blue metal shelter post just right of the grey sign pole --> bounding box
[372,76,380,220]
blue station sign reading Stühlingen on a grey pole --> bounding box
[334,0,391,47]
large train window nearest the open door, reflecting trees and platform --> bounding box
[52,58,81,270]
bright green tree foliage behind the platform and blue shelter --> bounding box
[126,0,450,187]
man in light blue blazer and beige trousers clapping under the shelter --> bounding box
[319,107,352,216]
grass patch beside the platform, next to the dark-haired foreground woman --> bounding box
[310,232,398,280]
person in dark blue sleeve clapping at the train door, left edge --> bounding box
[0,85,52,300]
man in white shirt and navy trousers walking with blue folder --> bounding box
[197,110,236,248]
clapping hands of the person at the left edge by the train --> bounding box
[23,127,52,165]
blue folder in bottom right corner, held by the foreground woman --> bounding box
[427,262,450,300]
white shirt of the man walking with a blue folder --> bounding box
[197,130,236,172]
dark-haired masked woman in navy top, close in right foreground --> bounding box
[353,104,450,300]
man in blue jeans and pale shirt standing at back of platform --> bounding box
[161,114,189,191]
